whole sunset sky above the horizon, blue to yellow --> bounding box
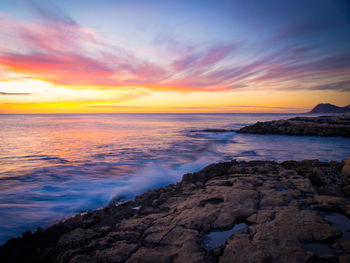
[0,0,350,113]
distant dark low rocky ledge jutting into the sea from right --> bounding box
[238,115,350,137]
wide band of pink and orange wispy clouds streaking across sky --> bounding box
[0,0,350,95]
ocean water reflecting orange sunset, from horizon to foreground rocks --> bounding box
[0,114,350,243]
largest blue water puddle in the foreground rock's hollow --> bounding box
[204,223,248,250]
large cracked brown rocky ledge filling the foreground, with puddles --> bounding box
[0,160,350,263]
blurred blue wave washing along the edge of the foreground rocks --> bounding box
[0,156,218,244]
